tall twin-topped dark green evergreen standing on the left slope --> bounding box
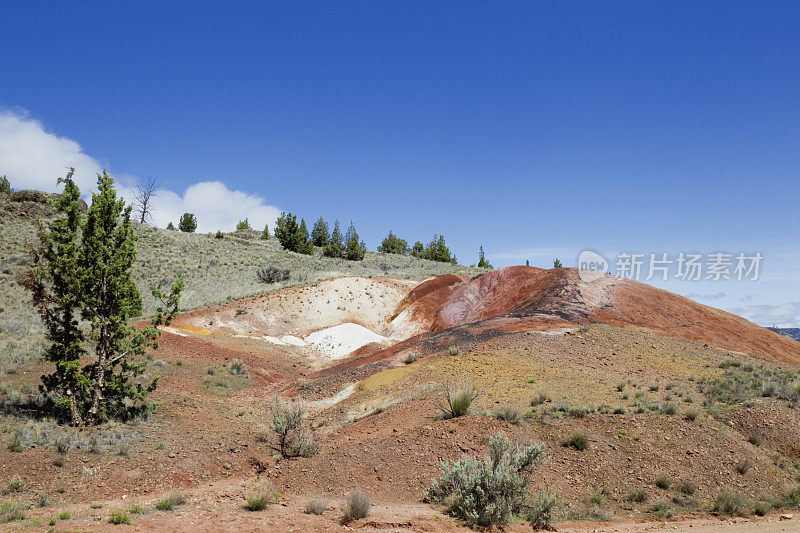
[31,170,183,425]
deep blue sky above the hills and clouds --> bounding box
[0,0,800,326]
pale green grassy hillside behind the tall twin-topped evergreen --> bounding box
[0,193,482,372]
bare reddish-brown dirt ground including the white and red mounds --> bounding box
[0,267,800,532]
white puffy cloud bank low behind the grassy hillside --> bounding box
[0,107,280,232]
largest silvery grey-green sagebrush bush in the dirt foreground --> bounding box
[425,432,545,527]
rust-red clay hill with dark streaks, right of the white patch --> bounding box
[392,266,800,364]
